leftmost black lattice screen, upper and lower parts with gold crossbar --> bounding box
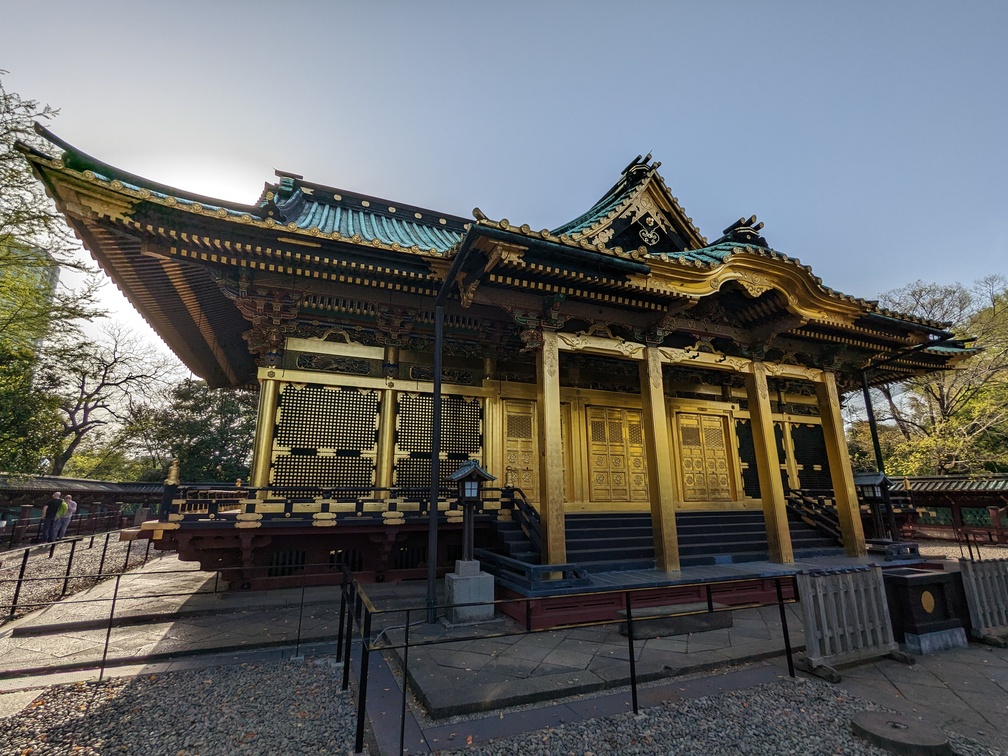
[271,384,379,489]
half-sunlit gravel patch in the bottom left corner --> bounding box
[0,659,356,756]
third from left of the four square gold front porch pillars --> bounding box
[745,362,794,564]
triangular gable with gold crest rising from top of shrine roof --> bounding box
[552,153,707,252]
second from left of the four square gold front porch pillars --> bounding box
[640,347,679,572]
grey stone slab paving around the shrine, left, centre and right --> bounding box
[0,557,1008,753]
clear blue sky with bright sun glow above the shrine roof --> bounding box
[0,0,1008,336]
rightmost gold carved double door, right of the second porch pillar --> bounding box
[676,412,734,501]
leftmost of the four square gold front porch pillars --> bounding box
[535,331,566,564]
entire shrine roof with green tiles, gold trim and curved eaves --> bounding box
[19,130,968,385]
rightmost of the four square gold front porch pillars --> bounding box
[815,373,867,556]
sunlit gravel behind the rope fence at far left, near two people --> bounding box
[0,531,162,625]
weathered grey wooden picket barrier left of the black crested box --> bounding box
[798,565,899,678]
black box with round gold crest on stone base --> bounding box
[882,568,969,654]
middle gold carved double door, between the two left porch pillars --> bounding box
[587,407,648,502]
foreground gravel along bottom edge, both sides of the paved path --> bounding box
[0,658,999,756]
